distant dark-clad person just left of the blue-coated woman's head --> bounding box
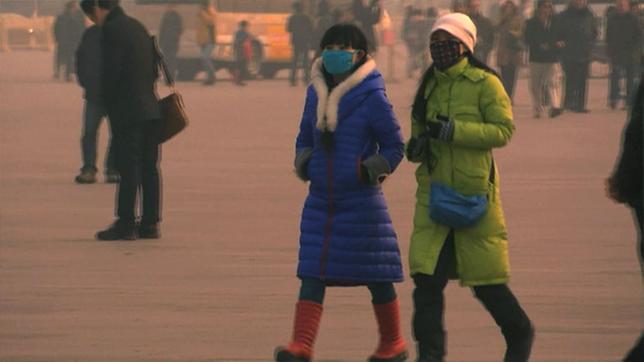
[286,1,313,86]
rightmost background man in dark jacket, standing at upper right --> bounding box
[606,0,642,109]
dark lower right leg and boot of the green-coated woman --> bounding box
[474,284,534,362]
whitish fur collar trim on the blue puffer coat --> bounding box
[311,57,376,132]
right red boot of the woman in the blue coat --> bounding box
[369,298,407,362]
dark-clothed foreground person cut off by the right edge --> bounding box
[607,77,644,362]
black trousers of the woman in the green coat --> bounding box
[413,233,532,361]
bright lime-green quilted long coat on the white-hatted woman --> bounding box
[409,58,514,286]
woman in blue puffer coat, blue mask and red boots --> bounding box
[275,24,407,362]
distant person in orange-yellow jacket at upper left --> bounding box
[197,0,217,85]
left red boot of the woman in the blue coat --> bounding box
[275,300,322,362]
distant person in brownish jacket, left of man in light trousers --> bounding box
[496,0,524,100]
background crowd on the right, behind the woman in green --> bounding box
[401,0,642,118]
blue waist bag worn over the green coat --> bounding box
[429,161,494,229]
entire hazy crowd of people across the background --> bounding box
[54,0,642,118]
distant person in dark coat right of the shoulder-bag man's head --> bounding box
[159,3,183,76]
